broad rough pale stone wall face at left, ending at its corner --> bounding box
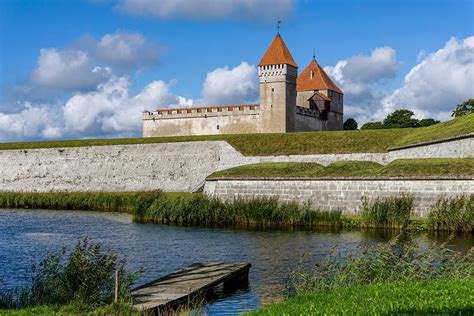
[0,142,228,192]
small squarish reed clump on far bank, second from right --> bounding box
[362,195,415,229]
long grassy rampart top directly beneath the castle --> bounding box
[0,114,474,156]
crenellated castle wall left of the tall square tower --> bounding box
[143,104,260,137]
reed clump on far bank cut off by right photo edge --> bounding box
[428,194,474,232]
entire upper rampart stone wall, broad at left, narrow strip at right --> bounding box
[0,134,474,192]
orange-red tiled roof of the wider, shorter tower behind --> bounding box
[296,59,344,93]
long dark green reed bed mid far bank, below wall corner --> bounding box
[134,194,342,227]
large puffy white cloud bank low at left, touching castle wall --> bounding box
[0,77,181,141]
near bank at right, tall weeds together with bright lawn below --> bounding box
[253,236,474,315]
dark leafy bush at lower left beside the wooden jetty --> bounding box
[0,238,142,308]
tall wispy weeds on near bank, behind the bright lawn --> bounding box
[291,236,474,294]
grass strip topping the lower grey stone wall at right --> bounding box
[208,158,474,179]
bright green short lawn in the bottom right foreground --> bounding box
[250,280,474,315]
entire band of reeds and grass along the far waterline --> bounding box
[0,191,474,232]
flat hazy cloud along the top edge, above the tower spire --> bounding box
[117,0,295,21]
